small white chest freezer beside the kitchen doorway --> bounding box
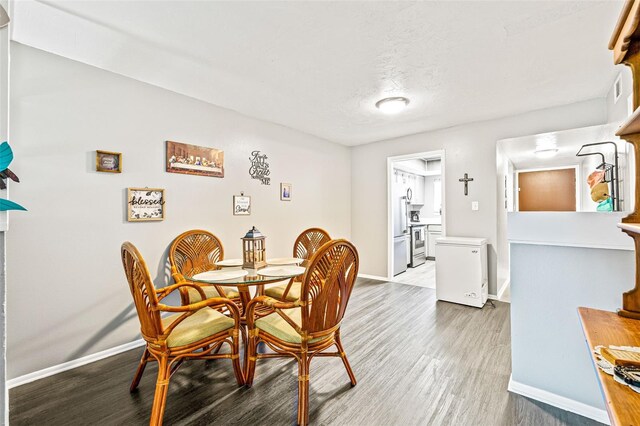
[436,237,489,308]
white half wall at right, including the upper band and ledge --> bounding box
[508,212,634,421]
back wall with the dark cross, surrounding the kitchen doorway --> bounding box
[351,99,606,294]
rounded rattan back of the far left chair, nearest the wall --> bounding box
[169,229,224,276]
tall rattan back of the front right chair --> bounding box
[301,240,359,335]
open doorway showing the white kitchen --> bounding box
[387,150,446,288]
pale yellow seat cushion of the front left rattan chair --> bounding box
[162,308,235,347]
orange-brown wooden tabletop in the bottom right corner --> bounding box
[578,308,640,426]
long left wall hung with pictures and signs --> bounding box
[7,43,351,379]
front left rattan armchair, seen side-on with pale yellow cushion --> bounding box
[121,242,244,425]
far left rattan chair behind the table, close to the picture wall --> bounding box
[169,229,240,304]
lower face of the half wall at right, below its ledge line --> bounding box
[509,243,634,421]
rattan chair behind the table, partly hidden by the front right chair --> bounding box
[264,228,331,301]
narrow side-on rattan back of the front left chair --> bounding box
[120,241,162,342]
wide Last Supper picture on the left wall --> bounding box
[167,141,224,178]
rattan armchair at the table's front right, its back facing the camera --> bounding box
[245,240,359,425]
